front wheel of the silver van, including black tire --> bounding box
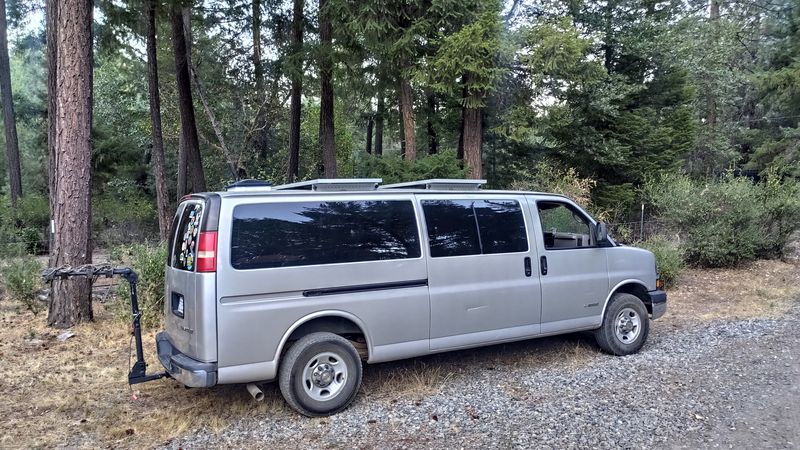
[594,293,650,356]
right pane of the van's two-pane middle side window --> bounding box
[473,200,528,254]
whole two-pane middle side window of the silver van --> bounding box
[422,200,528,258]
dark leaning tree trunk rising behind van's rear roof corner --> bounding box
[172,6,206,196]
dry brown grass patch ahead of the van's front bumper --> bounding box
[665,260,800,322]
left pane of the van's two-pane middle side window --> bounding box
[422,200,481,258]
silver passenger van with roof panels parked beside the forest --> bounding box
[156,179,667,416]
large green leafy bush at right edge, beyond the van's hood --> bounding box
[643,174,800,267]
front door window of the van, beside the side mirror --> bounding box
[537,202,594,250]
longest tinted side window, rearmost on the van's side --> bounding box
[231,200,420,269]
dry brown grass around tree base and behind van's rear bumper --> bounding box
[0,301,289,447]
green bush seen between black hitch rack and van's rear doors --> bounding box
[111,244,167,328]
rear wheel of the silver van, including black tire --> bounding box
[278,333,361,417]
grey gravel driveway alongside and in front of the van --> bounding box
[170,305,800,448]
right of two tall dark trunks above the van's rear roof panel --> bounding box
[319,0,336,178]
